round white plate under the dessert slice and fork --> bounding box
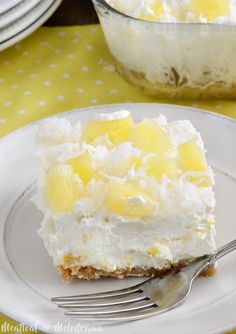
[0,104,236,334]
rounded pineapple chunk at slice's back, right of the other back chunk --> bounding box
[130,118,171,154]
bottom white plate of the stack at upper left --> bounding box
[0,0,62,51]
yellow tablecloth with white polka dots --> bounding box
[0,25,236,334]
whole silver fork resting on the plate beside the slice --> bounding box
[52,240,236,321]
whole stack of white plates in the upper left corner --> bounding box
[0,0,62,50]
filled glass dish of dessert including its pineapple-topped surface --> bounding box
[93,0,236,99]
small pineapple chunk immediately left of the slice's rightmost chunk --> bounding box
[147,156,177,182]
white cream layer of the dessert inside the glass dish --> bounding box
[100,0,236,89]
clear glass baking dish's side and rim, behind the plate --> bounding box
[93,0,236,99]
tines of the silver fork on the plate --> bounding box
[52,285,157,320]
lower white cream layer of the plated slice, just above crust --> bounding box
[39,213,215,271]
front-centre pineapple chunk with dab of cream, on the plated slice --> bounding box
[105,180,157,218]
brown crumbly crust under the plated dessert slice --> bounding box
[57,262,215,283]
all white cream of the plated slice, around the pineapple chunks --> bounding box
[35,111,215,271]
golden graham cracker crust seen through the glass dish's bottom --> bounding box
[113,57,236,99]
